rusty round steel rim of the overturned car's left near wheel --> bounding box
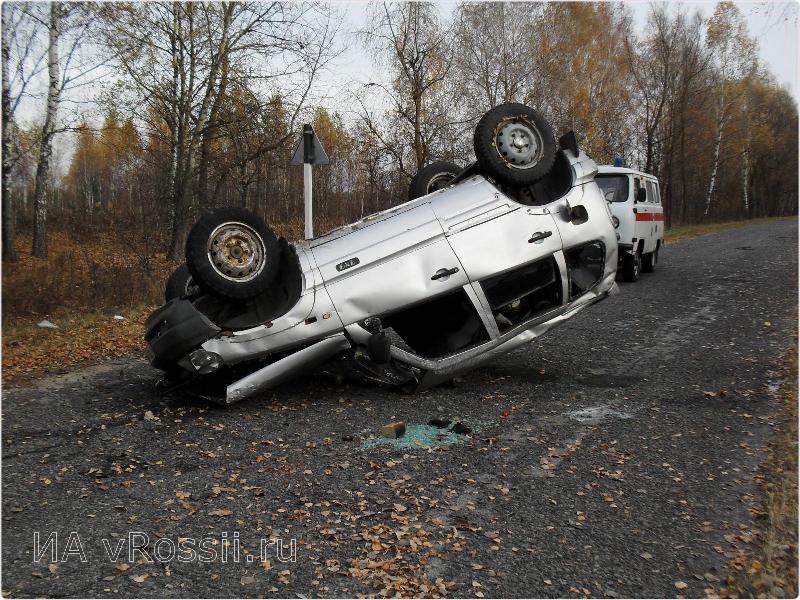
[208,222,266,283]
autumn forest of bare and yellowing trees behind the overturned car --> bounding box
[2,2,798,319]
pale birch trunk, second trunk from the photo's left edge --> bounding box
[31,2,61,258]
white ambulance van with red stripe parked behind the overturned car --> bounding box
[595,165,664,281]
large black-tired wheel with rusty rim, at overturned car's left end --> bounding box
[186,208,280,300]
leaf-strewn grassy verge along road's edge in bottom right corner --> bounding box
[723,334,798,598]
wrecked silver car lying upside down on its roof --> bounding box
[145,104,618,403]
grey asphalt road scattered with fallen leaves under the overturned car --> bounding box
[2,220,798,597]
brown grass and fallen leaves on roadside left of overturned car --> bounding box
[2,231,176,384]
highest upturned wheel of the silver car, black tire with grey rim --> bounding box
[473,103,557,186]
